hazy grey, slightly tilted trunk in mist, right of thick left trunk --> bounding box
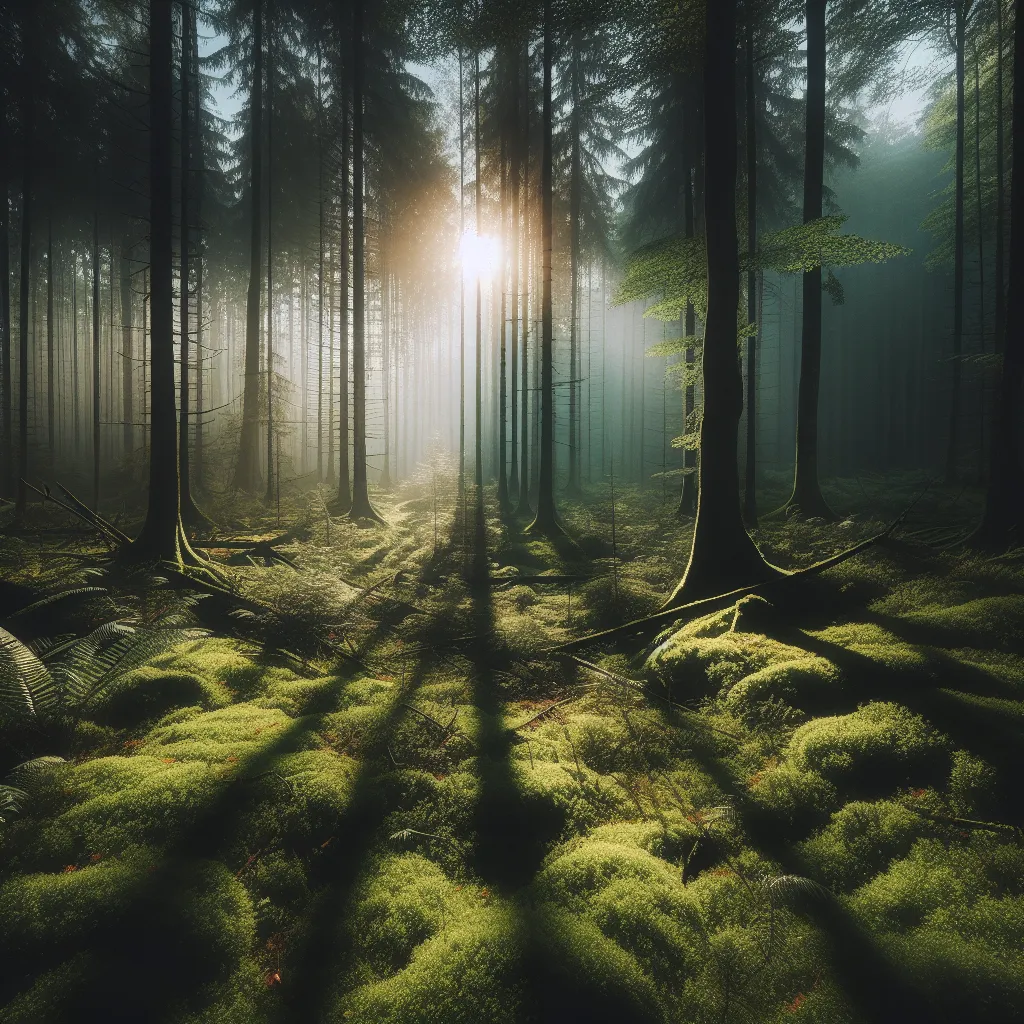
[233,0,263,490]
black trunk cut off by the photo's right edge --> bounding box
[972,0,1024,550]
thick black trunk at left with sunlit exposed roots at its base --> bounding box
[121,0,198,566]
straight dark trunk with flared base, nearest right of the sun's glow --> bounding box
[530,0,560,532]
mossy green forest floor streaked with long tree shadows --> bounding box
[0,479,1024,1024]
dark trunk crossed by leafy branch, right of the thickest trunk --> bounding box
[786,0,836,522]
